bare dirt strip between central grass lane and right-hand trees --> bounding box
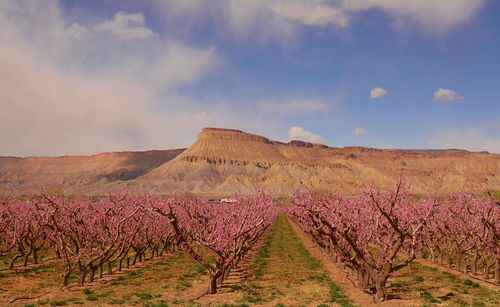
[290,221,421,307]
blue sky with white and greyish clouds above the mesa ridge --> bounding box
[0,0,500,156]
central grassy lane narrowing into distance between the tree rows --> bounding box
[240,213,352,306]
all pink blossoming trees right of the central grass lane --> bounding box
[287,181,500,301]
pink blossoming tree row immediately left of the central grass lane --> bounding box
[153,192,279,294]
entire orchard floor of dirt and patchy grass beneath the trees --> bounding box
[0,215,500,307]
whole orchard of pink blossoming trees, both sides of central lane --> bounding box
[0,180,500,303]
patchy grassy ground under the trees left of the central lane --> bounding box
[0,252,206,306]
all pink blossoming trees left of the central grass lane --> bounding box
[0,193,277,293]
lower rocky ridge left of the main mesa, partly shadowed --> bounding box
[0,149,184,193]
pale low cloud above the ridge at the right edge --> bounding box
[427,128,500,153]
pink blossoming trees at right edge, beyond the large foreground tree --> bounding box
[421,192,500,284]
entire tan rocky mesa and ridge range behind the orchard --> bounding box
[0,128,500,195]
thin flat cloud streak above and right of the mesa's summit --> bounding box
[258,99,330,116]
